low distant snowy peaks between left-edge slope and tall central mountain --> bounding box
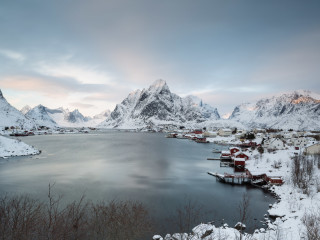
[26,105,97,128]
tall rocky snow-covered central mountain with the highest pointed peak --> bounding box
[99,80,220,128]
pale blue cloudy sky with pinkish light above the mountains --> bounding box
[0,0,320,116]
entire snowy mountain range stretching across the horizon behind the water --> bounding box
[0,83,320,130]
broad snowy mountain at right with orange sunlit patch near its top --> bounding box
[229,90,320,130]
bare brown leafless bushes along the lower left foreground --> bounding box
[0,186,152,240]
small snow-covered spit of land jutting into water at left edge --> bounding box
[0,136,39,158]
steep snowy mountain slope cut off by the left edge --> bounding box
[0,90,34,129]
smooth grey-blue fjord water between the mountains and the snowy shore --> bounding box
[0,131,274,234]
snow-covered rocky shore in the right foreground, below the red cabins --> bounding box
[153,138,320,240]
